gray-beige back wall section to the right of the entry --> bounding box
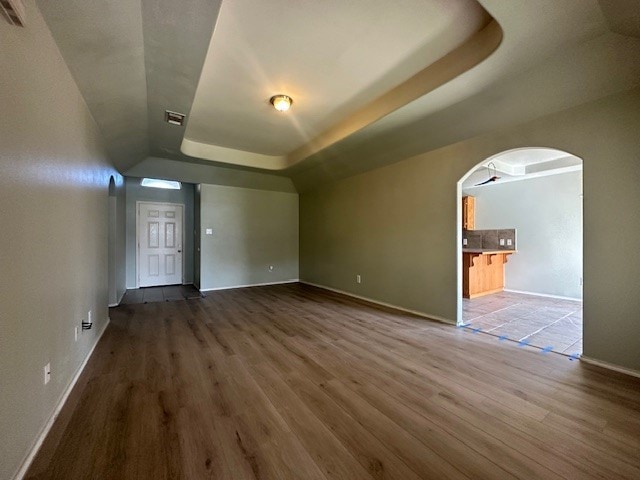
[200,185,298,290]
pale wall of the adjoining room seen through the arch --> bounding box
[465,171,582,299]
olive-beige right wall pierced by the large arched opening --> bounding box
[300,89,640,369]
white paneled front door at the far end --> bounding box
[137,202,184,287]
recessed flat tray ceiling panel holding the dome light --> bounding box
[185,0,490,155]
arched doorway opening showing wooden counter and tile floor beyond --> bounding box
[458,147,583,356]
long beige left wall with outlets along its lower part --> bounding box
[0,0,123,480]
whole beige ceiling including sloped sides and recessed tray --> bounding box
[37,0,640,191]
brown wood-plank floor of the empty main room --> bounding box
[27,284,640,480]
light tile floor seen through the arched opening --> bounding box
[462,292,582,355]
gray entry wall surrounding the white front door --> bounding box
[125,177,194,288]
